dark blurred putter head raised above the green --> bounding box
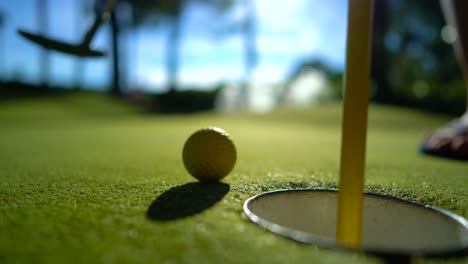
[18,29,106,58]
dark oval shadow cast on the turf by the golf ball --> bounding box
[146,182,230,221]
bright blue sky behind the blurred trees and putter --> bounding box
[0,0,347,90]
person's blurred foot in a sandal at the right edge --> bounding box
[421,114,468,160]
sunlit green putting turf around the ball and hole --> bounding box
[0,94,468,263]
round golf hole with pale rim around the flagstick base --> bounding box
[244,190,468,257]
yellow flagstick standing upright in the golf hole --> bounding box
[336,0,372,248]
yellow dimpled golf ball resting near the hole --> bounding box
[182,127,236,181]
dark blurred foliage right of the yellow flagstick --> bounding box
[372,0,466,114]
